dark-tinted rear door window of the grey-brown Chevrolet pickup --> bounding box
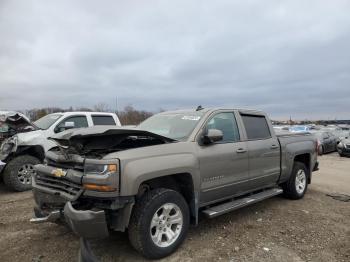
[241,114,271,140]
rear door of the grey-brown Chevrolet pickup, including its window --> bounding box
[240,113,280,189]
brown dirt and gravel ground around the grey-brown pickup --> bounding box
[0,154,350,262]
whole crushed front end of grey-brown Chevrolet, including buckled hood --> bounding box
[32,126,174,238]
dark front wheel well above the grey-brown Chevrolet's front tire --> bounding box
[138,173,195,216]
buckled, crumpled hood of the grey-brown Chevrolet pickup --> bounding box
[49,126,176,155]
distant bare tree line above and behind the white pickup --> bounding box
[23,103,154,125]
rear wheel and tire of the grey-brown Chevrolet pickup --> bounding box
[282,162,309,199]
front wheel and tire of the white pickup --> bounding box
[3,155,41,192]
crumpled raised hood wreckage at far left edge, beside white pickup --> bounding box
[0,111,36,142]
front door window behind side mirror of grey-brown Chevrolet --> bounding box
[207,113,240,142]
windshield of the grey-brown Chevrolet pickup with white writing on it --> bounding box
[138,112,203,141]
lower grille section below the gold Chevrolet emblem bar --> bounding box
[35,173,82,198]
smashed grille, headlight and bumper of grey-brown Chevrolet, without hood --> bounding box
[31,149,134,238]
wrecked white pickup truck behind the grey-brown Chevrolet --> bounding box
[0,112,120,191]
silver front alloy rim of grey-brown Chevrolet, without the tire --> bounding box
[150,203,183,247]
